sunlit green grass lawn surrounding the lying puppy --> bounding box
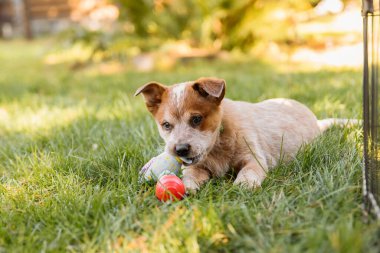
[0,41,380,252]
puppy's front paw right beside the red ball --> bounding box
[182,166,210,193]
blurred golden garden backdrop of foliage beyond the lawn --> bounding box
[0,0,362,73]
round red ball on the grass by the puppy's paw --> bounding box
[156,175,186,201]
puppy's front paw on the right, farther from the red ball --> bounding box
[234,161,266,188]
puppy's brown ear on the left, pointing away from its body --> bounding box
[135,82,167,114]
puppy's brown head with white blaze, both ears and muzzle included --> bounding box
[135,78,226,165]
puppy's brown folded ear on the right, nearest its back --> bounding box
[193,77,226,104]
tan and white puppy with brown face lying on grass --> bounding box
[135,78,333,192]
